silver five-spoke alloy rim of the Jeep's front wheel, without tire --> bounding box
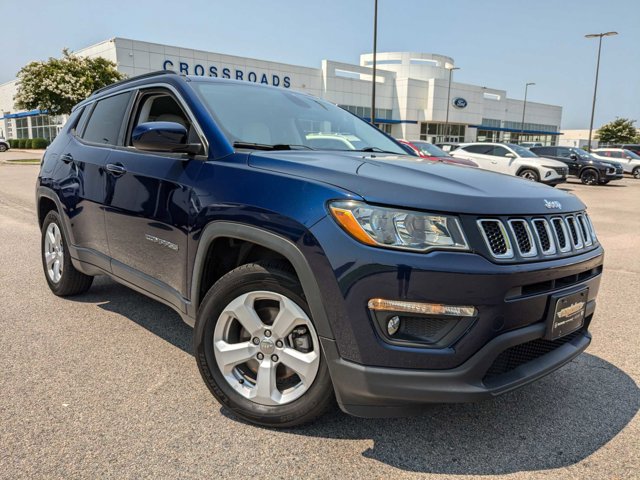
[213,291,320,405]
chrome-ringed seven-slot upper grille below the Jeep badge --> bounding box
[477,213,596,259]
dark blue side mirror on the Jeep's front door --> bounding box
[131,122,202,155]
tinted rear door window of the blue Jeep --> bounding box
[82,92,131,145]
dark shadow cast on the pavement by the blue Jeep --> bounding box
[74,277,640,475]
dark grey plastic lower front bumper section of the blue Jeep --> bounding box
[322,308,595,417]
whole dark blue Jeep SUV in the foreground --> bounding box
[37,72,603,426]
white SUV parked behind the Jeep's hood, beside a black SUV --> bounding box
[450,142,569,186]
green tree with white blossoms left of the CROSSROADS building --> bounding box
[14,48,124,115]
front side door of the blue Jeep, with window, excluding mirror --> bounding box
[105,88,206,307]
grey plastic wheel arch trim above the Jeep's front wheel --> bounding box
[187,221,334,339]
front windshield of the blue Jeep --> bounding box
[193,82,405,155]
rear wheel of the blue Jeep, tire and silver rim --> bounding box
[40,210,93,297]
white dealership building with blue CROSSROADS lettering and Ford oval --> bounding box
[0,38,562,145]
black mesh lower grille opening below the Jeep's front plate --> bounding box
[483,330,582,383]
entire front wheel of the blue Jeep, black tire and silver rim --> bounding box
[194,261,335,427]
